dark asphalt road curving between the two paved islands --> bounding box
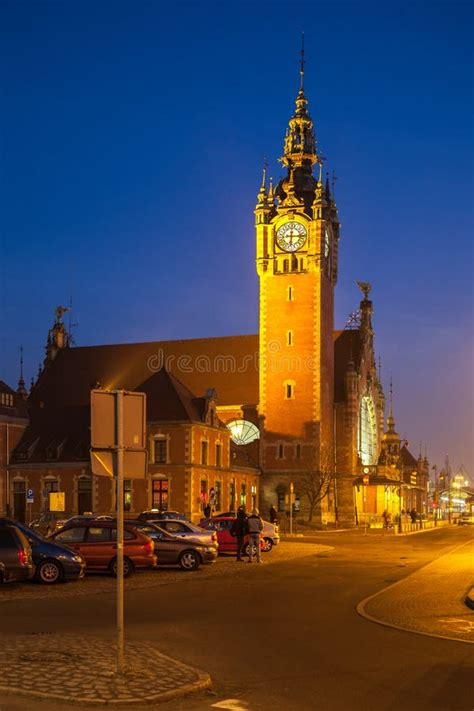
[0,528,474,711]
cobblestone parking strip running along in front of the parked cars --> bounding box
[0,542,334,603]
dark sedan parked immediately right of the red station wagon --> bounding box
[122,521,217,570]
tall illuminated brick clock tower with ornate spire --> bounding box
[255,52,339,510]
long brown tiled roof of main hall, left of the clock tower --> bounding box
[32,335,258,406]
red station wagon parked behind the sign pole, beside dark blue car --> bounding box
[51,520,156,576]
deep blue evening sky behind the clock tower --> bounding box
[0,0,474,474]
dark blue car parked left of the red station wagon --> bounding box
[0,518,86,585]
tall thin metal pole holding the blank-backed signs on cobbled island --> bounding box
[115,390,124,674]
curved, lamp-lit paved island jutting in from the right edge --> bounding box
[357,540,474,643]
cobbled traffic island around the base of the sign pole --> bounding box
[0,634,211,706]
